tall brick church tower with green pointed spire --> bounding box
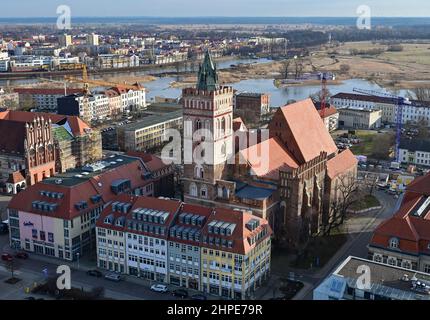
[182,52,233,205]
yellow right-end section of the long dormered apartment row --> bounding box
[200,209,271,300]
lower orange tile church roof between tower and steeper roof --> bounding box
[240,137,299,180]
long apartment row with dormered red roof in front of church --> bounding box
[97,195,272,299]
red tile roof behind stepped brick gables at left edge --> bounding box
[0,110,91,135]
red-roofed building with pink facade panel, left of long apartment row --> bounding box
[7,155,165,262]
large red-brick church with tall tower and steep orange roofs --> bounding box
[182,52,357,247]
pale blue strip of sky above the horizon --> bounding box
[0,0,430,18]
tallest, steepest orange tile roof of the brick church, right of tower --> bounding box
[269,99,338,162]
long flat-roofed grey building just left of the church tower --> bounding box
[117,111,182,151]
